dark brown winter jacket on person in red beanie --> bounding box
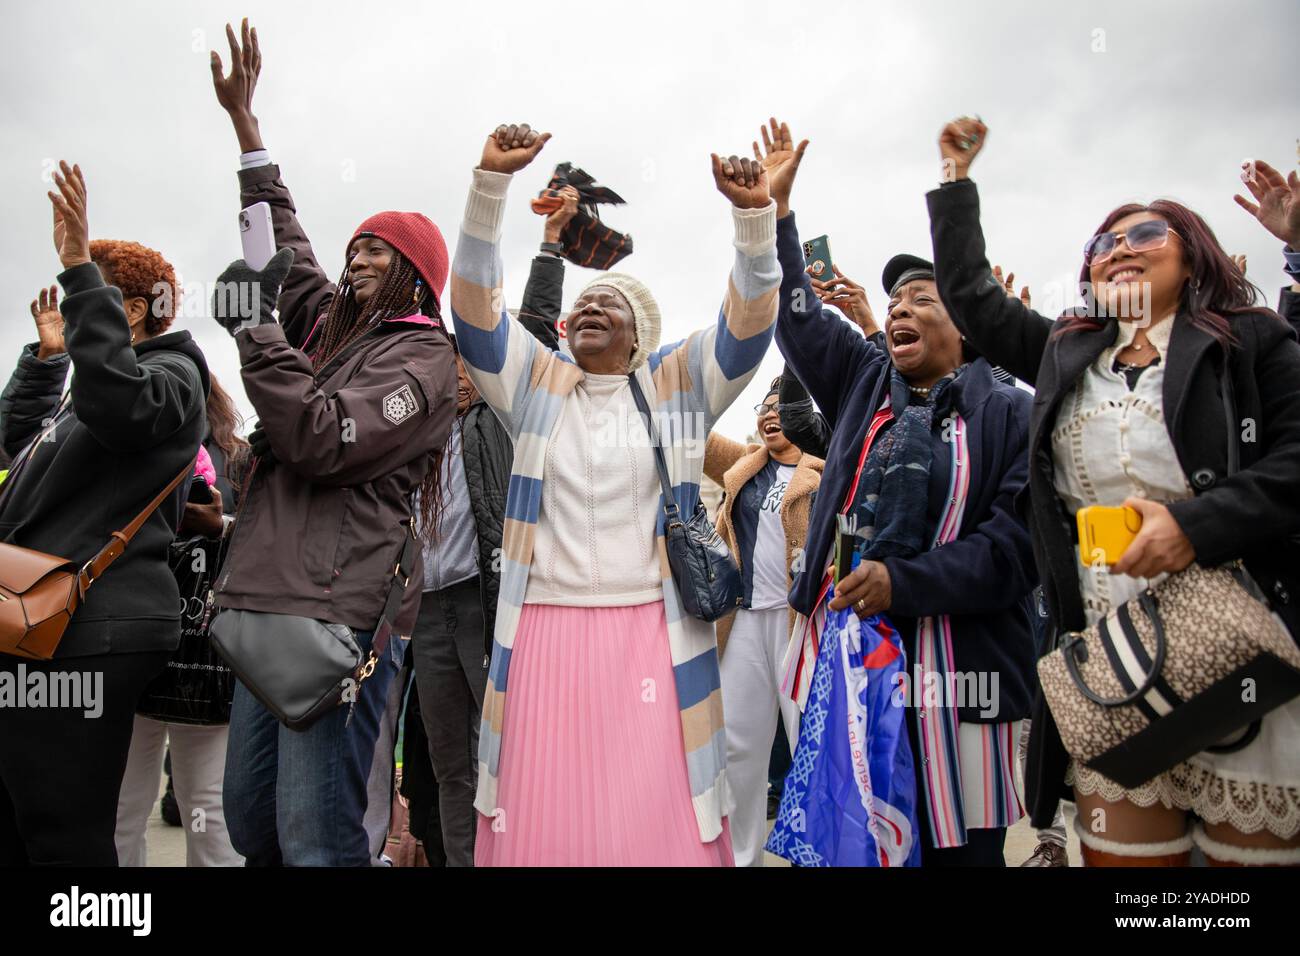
[217,166,456,633]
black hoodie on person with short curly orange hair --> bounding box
[0,263,209,658]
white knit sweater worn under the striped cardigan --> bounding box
[524,373,664,607]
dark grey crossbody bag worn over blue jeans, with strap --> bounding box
[212,522,417,731]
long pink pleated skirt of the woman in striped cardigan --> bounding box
[475,601,735,866]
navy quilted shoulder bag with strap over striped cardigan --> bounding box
[628,373,745,624]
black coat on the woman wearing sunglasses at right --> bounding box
[927,179,1300,826]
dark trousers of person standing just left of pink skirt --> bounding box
[411,576,488,866]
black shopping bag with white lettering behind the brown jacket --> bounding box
[135,535,235,726]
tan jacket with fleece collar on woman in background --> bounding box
[705,432,824,658]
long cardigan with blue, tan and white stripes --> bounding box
[451,169,781,843]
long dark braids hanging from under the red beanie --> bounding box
[312,248,446,541]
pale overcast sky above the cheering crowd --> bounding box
[0,0,1300,437]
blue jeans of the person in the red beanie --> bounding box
[224,631,403,866]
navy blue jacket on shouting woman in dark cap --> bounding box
[776,213,1036,722]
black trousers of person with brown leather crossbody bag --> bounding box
[0,650,172,866]
